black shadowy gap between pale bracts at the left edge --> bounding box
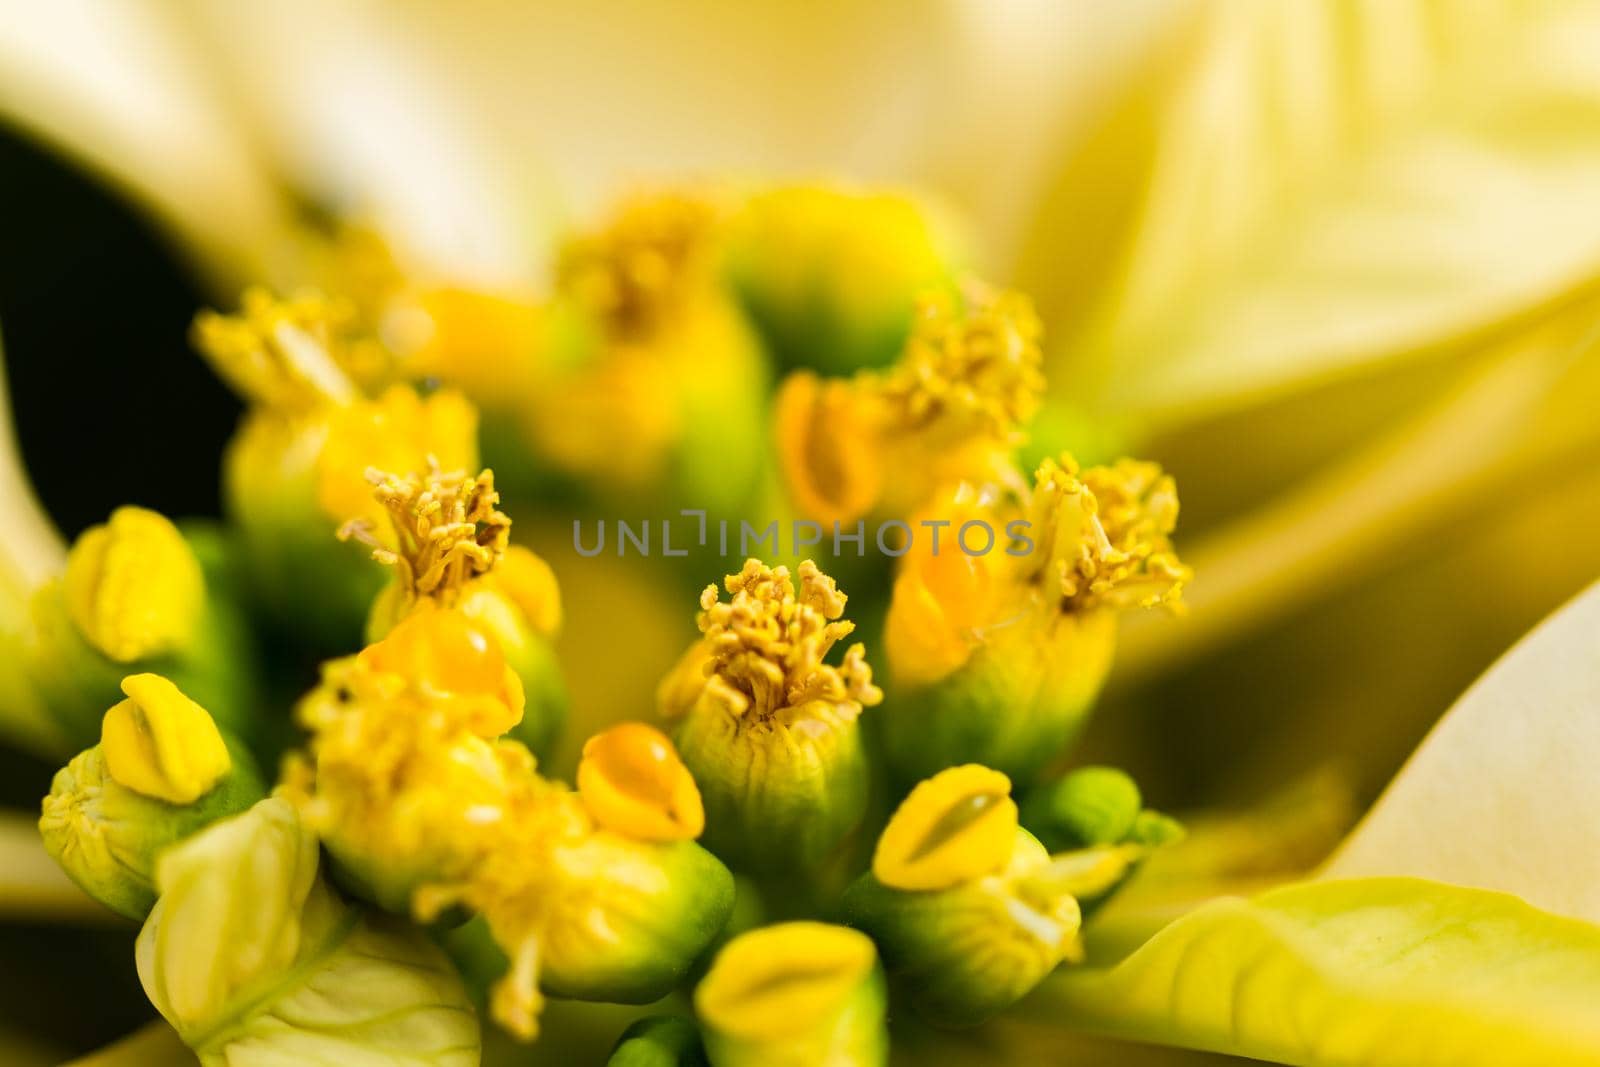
[0,119,240,537]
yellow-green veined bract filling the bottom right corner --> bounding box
[1032,878,1600,1067]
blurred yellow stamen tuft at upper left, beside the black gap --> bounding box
[194,288,366,410]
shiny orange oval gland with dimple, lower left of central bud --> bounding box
[578,723,706,841]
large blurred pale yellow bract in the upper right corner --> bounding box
[1021,0,1600,422]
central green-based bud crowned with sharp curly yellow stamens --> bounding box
[662,560,882,873]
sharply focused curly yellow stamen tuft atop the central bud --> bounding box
[699,560,883,718]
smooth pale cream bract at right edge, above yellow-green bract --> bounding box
[1326,585,1600,923]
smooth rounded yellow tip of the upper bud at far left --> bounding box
[66,507,205,664]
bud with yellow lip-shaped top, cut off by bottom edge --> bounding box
[694,923,888,1067]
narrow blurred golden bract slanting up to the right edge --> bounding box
[1118,307,1600,675]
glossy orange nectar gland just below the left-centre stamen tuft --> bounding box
[360,608,523,737]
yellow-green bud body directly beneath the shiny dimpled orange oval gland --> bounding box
[539,832,734,1005]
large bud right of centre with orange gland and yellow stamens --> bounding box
[882,456,1190,784]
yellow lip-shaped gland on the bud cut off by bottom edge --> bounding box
[694,923,877,1041]
